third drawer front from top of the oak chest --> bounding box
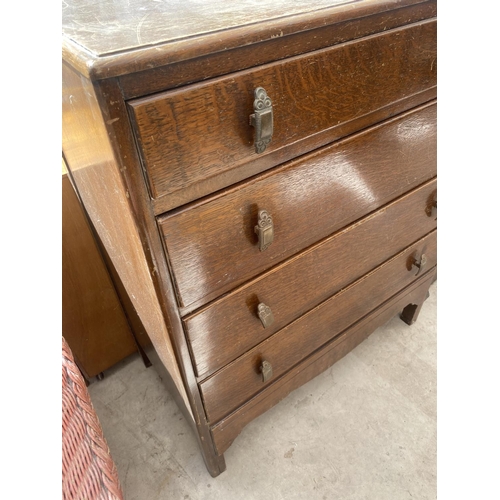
[184,180,436,377]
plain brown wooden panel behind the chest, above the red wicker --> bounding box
[61,170,137,378]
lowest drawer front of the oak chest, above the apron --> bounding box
[200,231,437,423]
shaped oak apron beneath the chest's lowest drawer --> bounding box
[212,270,435,455]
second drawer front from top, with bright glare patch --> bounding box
[158,104,436,307]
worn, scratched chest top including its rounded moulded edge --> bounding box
[62,0,435,80]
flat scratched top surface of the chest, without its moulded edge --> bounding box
[62,0,360,56]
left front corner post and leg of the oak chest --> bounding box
[98,79,226,477]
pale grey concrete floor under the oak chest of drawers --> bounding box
[89,283,437,500]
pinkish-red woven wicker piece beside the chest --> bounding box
[62,338,123,500]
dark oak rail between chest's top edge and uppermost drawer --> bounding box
[119,0,437,99]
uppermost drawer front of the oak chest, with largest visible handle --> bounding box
[129,21,436,203]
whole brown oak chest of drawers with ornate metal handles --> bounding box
[63,0,437,475]
